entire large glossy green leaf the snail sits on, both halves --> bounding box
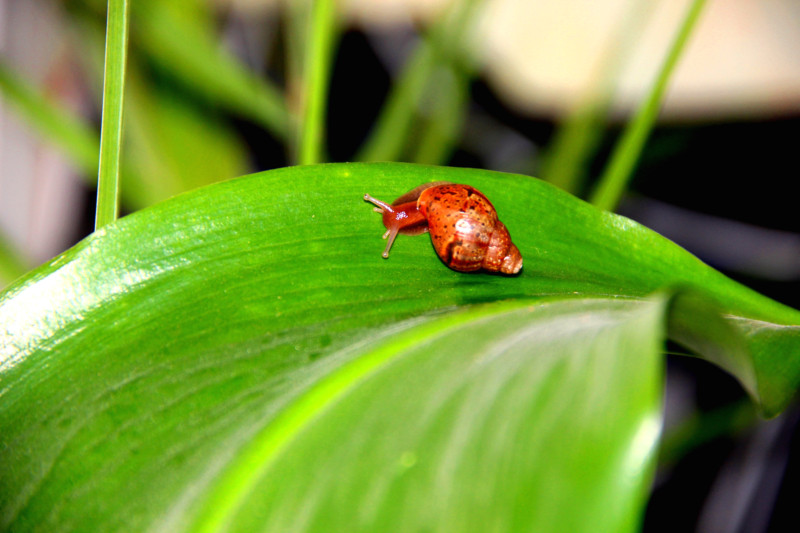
[0,163,800,531]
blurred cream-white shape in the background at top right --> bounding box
[239,0,800,120]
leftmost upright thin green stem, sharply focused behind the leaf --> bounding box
[95,0,128,230]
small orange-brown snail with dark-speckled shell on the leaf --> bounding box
[364,181,522,274]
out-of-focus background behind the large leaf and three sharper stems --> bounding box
[0,0,800,533]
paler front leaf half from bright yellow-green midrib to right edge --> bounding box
[195,299,664,532]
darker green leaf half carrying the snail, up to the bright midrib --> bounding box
[0,163,800,530]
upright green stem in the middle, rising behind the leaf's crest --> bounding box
[298,0,336,165]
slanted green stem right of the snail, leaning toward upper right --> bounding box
[590,0,706,211]
